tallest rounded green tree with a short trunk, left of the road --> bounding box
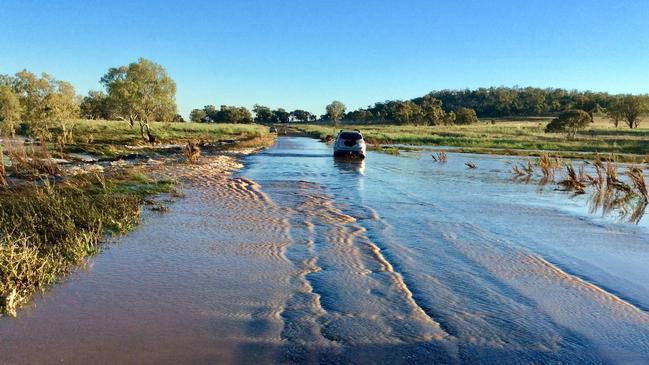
[101,58,176,142]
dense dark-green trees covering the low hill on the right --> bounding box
[343,87,649,128]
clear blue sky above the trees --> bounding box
[0,0,649,116]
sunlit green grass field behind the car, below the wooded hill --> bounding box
[293,118,649,162]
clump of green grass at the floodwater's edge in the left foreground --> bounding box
[0,172,174,315]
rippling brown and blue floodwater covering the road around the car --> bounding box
[0,137,649,364]
